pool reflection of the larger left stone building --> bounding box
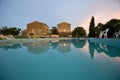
[23,40,49,54]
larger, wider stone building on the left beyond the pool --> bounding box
[23,21,48,38]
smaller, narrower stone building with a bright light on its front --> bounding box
[57,22,72,37]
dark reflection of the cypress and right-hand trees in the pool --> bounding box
[88,41,120,59]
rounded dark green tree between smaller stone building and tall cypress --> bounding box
[72,27,86,37]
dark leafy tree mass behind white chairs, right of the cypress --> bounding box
[95,19,120,38]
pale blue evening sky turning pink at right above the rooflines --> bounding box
[0,0,120,33]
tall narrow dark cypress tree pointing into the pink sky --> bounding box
[88,16,95,37]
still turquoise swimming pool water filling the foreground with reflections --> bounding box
[0,39,120,80]
